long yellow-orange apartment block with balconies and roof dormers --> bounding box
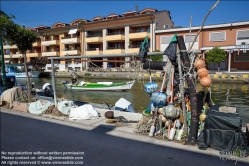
[4,8,174,71]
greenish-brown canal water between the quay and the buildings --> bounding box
[17,78,249,124]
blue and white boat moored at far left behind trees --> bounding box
[5,64,42,78]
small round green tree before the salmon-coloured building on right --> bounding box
[206,47,226,71]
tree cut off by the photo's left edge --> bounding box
[0,10,15,91]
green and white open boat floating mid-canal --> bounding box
[63,80,135,91]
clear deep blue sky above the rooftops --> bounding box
[0,0,249,28]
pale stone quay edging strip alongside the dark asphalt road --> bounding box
[0,107,249,163]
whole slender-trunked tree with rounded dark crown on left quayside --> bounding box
[8,25,37,102]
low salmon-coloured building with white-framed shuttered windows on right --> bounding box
[155,21,249,71]
